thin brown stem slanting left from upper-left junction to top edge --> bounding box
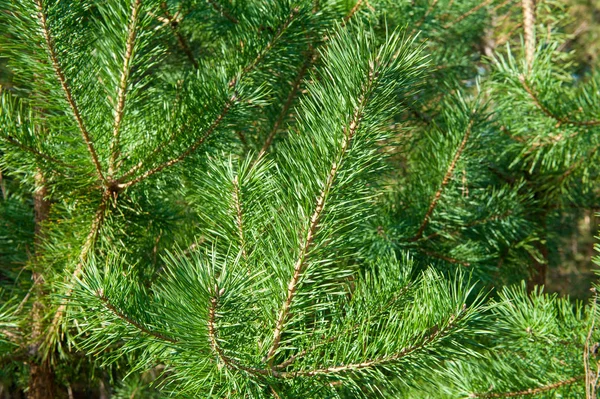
[35,0,108,186]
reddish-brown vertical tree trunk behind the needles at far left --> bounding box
[28,171,55,399]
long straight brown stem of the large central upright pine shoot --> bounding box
[266,63,375,365]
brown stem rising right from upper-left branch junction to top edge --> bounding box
[108,0,142,178]
